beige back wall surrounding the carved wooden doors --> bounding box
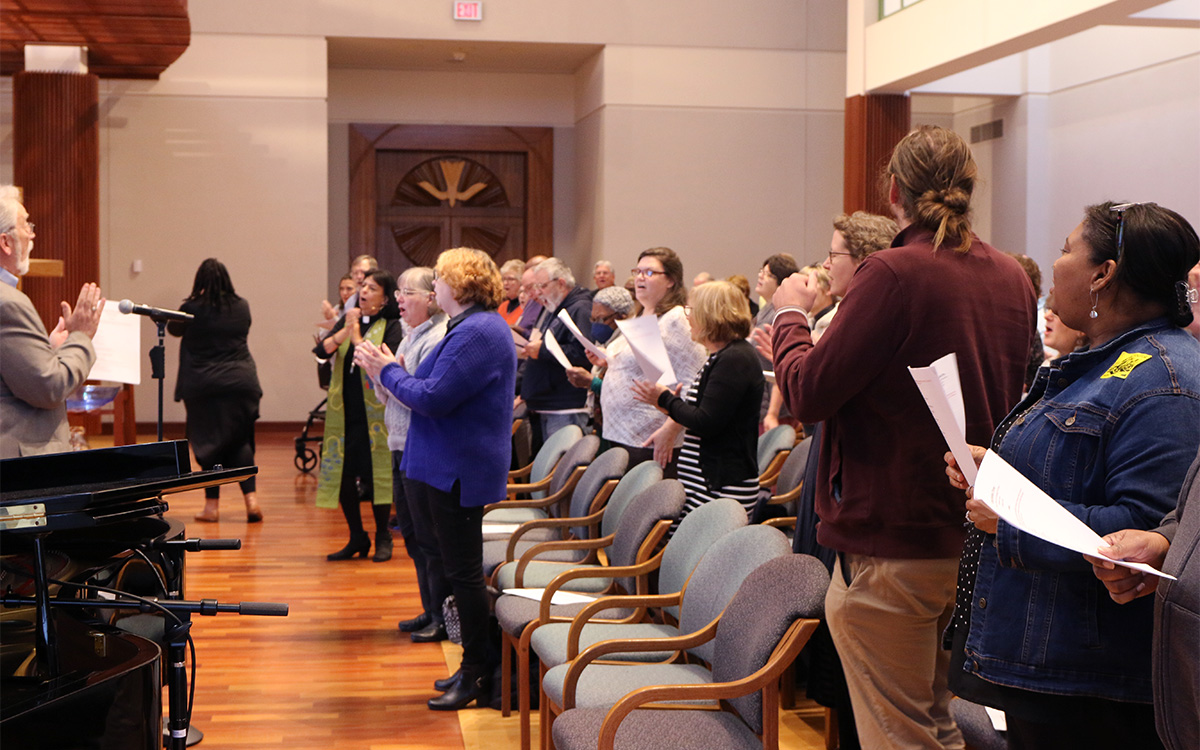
[0,0,846,422]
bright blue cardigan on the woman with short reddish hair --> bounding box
[379,311,517,508]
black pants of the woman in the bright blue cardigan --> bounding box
[406,480,494,674]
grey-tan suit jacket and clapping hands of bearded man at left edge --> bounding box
[0,282,96,458]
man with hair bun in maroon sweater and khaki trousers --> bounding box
[772,127,1037,749]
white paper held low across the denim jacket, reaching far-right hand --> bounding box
[974,450,1175,581]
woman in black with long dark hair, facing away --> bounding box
[167,258,263,523]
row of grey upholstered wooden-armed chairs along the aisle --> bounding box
[475,427,828,749]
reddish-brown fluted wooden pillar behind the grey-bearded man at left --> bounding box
[12,72,100,330]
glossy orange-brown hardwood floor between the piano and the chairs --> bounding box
[162,432,823,750]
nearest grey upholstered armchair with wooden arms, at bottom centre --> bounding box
[553,552,829,750]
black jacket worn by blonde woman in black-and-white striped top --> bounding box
[659,338,767,492]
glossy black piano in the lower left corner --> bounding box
[0,440,262,750]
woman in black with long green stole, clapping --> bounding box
[313,269,404,563]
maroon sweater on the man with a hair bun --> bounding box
[772,226,1037,558]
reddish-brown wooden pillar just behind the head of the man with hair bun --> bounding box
[842,94,912,216]
